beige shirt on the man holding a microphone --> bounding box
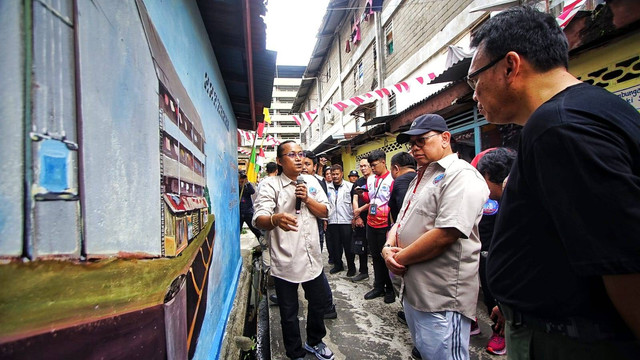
[252,174,329,283]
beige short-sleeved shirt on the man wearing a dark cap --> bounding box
[398,154,489,320]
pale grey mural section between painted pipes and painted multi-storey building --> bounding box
[78,0,161,256]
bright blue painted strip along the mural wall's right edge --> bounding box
[145,0,241,359]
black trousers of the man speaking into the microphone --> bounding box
[273,272,327,359]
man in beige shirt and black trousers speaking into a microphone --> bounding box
[253,141,334,360]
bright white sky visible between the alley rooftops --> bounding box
[265,0,329,66]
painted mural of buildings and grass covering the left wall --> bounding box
[0,0,246,359]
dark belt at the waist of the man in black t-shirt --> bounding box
[499,303,621,341]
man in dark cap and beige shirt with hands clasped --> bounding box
[382,114,489,360]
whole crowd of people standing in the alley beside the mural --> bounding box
[240,7,640,359]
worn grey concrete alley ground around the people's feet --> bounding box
[268,251,506,360]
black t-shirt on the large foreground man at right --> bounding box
[487,84,640,333]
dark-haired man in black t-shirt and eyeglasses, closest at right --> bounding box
[468,7,640,360]
